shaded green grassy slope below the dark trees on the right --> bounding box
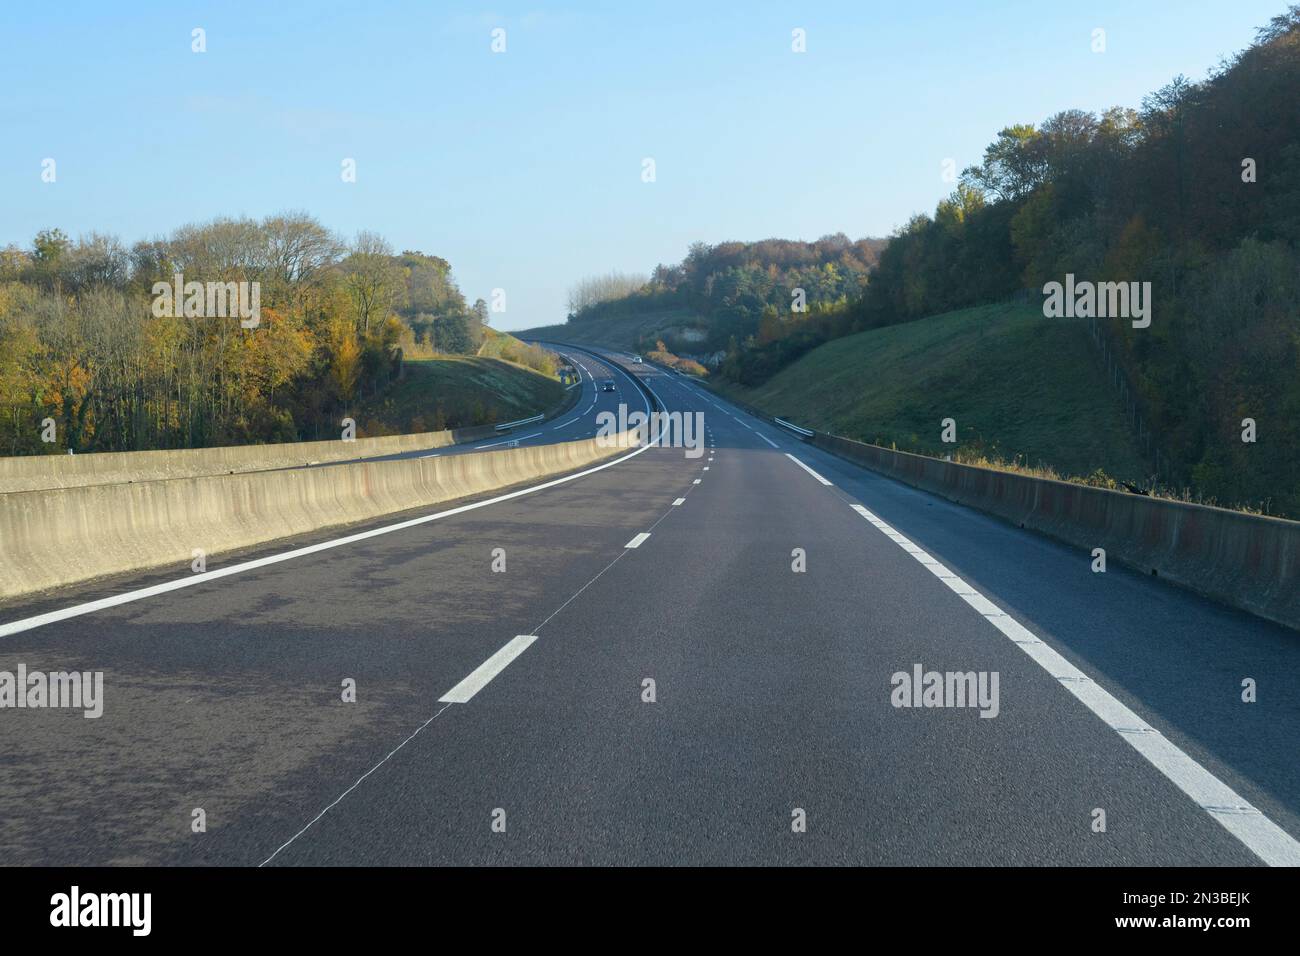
[723,306,1147,481]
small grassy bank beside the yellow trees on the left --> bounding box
[355,355,564,437]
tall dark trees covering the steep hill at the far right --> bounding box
[850,5,1300,514]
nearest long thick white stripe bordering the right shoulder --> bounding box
[853,505,1300,866]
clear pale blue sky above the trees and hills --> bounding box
[0,0,1287,328]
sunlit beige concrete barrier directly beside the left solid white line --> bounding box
[0,438,639,598]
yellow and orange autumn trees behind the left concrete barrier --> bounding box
[0,213,486,454]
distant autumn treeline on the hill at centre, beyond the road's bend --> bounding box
[569,233,884,354]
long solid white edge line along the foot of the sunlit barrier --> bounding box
[0,369,667,637]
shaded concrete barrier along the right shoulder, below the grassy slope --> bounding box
[813,432,1300,628]
